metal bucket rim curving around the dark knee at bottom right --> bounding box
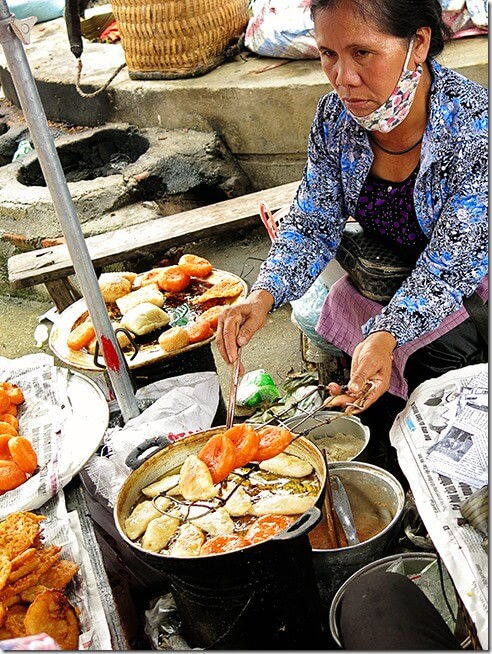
[330,552,470,649]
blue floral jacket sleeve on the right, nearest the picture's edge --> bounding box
[363,64,488,345]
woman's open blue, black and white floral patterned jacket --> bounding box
[252,60,488,345]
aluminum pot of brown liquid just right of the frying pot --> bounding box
[309,461,405,607]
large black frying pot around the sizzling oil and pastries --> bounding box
[114,427,326,649]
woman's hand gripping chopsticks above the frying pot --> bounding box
[216,290,273,374]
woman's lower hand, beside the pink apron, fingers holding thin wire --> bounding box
[328,332,396,413]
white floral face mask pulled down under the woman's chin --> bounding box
[347,39,422,133]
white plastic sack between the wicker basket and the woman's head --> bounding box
[244,0,319,59]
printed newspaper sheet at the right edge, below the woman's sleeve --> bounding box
[390,364,488,650]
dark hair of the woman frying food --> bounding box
[311,0,452,58]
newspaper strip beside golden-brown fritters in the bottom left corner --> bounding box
[36,490,112,651]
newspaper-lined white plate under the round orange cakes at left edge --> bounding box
[0,354,109,519]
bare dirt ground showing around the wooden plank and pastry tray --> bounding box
[0,225,304,396]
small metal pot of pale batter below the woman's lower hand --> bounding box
[284,411,370,462]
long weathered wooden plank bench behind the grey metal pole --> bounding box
[8,182,299,288]
